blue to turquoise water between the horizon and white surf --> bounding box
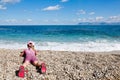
[0,25,120,51]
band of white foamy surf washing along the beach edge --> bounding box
[0,40,120,52]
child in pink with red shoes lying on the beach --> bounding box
[18,41,46,78]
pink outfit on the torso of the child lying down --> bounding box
[24,49,37,62]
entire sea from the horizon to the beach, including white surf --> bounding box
[0,25,120,52]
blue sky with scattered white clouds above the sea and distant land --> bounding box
[0,0,120,25]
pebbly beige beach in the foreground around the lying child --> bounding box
[0,49,120,80]
